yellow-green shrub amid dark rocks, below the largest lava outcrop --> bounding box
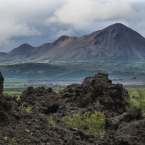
[64,111,105,135]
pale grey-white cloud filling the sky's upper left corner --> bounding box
[0,0,61,46]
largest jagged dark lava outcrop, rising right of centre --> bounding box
[62,73,129,117]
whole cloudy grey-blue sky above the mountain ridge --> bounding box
[0,0,145,52]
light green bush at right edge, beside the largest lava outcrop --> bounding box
[128,88,145,115]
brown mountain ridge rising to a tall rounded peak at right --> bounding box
[1,23,145,62]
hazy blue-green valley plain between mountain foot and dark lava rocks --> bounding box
[0,62,145,91]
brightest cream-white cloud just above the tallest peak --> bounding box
[48,0,134,25]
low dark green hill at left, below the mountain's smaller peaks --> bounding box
[0,63,66,79]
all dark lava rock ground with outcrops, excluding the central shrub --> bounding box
[0,73,145,145]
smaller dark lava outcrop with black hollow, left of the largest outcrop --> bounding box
[20,86,59,115]
